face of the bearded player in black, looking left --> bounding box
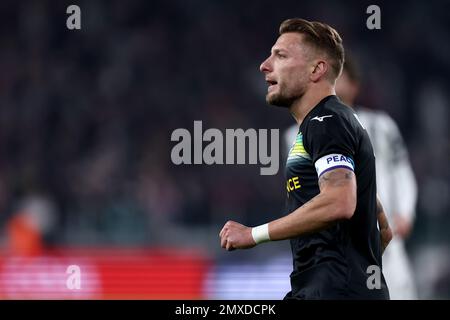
[260,32,311,107]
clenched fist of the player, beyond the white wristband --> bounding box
[219,221,256,251]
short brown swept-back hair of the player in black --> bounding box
[280,18,344,79]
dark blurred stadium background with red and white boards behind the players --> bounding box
[0,0,450,299]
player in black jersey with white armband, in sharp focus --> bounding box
[219,18,392,299]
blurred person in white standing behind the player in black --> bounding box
[284,54,418,300]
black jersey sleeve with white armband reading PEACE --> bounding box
[304,114,357,177]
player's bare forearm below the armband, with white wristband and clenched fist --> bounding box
[219,168,356,250]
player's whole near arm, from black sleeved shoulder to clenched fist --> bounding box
[219,111,357,250]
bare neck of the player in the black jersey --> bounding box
[289,83,336,125]
